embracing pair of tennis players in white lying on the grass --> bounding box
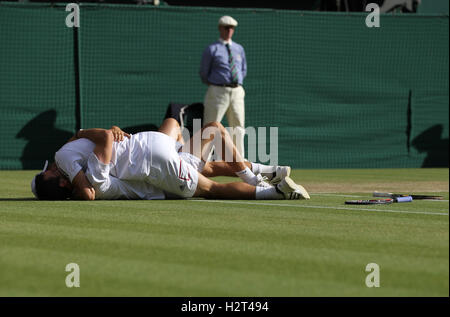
[32,118,309,200]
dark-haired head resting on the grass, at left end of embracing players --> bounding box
[31,162,72,200]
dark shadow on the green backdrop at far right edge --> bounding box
[412,124,448,167]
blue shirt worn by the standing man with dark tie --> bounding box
[200,40,247,85]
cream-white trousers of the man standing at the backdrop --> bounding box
[203,85,245,157]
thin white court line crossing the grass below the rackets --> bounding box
[188,199,448,216]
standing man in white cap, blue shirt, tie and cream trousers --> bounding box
[200,16,247,157]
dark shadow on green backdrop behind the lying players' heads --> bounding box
[16,109,73,169]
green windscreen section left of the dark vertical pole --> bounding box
[0,3,75,169]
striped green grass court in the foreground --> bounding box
[0,169,449,297]
